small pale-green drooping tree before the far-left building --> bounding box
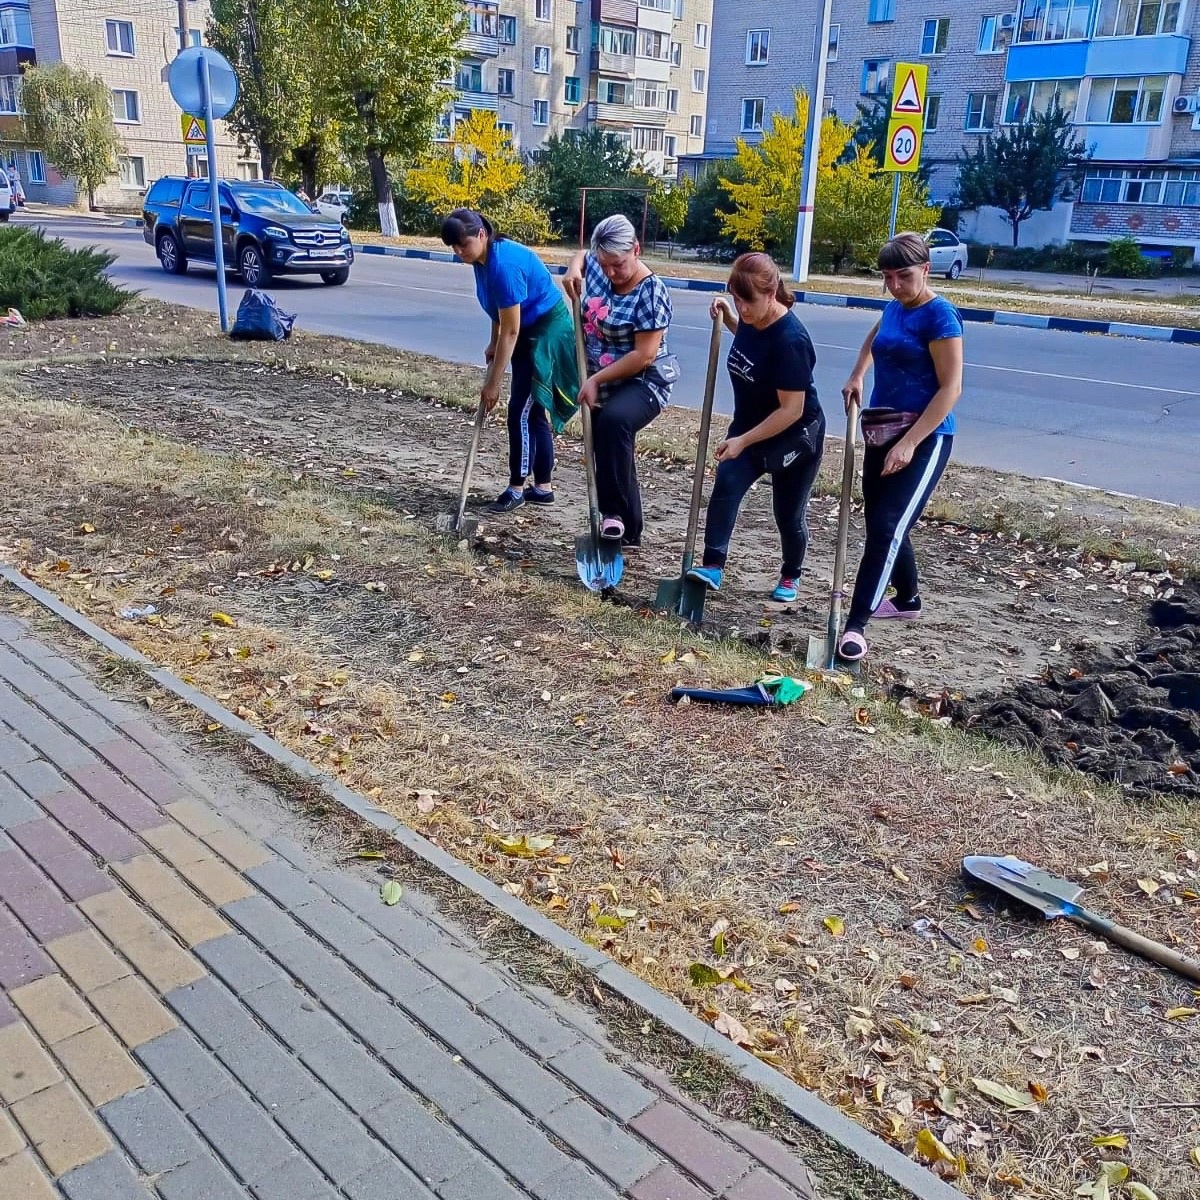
[22,62,125,209]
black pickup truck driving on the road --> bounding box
[142,175,354,288]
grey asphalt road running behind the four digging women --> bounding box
[18,215,1200,505]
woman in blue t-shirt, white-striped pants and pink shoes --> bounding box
[838,233,962,662]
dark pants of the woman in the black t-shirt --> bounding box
[703,421,824,580]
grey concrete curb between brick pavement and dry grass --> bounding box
[0,566,962,1200]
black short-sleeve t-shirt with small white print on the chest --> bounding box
[726,312,821,437]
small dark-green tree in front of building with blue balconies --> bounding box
[955,103,1091,247]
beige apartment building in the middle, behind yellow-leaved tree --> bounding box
[443,0,713,174]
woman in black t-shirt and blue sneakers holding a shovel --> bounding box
[688,254,824,604]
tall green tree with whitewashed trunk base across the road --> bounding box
[307,0,466,235]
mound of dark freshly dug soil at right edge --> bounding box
[959,583,1200,797]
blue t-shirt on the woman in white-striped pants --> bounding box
[868,296,962,433]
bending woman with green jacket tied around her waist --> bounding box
[442,209,580,512]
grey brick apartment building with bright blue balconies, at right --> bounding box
[686,0,1200,255]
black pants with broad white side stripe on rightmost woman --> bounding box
[846,433,954,632]
